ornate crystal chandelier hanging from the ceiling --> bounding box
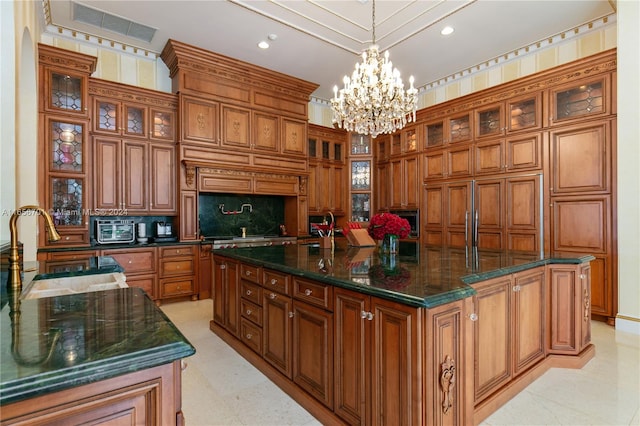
[331,0,418,138]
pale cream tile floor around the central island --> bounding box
[162,299,640,426]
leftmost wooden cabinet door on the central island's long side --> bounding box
[213,255,240,336]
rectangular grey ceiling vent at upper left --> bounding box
[73,3,157,43]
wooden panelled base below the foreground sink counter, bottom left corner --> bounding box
[0,360,185,426]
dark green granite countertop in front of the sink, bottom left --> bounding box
[0,288,195,405]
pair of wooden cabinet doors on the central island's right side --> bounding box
[473,267,546,406]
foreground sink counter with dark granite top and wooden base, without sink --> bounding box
[0,257,195,425]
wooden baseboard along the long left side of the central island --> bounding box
[209,320,344,425]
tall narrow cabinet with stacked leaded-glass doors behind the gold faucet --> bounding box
[38,44,97,247]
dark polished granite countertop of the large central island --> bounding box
[214,240,593,308]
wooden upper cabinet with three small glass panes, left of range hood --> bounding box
[90,79,177,216]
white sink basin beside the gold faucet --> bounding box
[22,272,128,299]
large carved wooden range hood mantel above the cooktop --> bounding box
[160,40,318,241]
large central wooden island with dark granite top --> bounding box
[210,242,595,425]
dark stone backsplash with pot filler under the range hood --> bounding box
[198,194,284,237]
